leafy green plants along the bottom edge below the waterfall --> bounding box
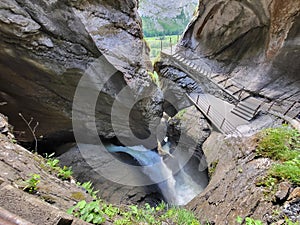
[67,182,200,225]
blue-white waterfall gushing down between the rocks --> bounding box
[106,145,207,205]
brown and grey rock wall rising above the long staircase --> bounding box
[179,0,300,101]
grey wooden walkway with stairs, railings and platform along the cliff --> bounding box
[162,50,300,131]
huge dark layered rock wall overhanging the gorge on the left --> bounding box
[0,0,161,144]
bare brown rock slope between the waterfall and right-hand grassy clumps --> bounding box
[187,132,299,224]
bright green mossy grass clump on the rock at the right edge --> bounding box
[257,126,300,185]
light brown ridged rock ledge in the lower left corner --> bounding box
[0,116,96,225]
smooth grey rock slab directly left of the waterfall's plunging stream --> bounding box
[59,145,163,205]
